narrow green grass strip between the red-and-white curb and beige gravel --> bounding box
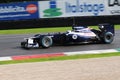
[0,52,120,65]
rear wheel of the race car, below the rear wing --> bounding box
[103,32,114,44]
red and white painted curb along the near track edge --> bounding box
[0,48,120,61]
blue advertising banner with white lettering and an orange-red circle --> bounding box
[0,2,39,20]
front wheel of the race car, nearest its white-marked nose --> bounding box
[40,36,53,48]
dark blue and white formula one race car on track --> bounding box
[21,24,115,49]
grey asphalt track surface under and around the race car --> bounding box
[0,30,120,57]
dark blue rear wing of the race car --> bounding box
[98,23,115,35]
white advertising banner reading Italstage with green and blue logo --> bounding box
[39,0,120,18]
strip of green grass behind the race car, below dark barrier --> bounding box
[0,25,120,34]
